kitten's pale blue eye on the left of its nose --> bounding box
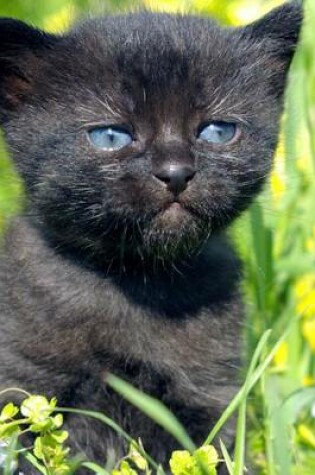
[88,126,133,152]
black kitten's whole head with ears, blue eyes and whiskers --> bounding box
[0,3,302,260]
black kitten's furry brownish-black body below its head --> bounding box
[0,221,240,460]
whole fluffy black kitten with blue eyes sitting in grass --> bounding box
[0,3,302,475]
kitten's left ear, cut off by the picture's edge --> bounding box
[0,18,56,121]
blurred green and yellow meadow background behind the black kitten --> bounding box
[0,0,315,475]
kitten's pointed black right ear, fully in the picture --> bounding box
[243,1,303,94]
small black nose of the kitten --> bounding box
[154,164,196,195]
